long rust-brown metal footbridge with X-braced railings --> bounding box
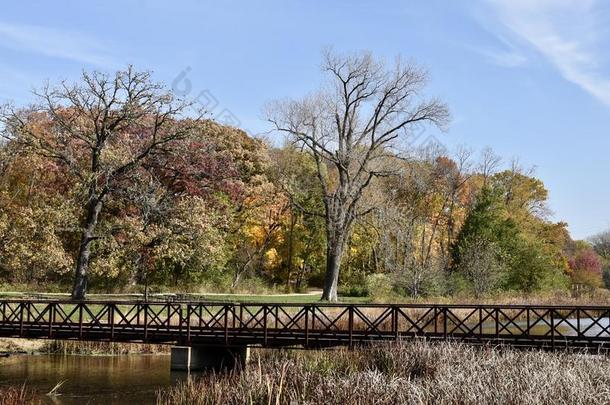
[0,300,610,369]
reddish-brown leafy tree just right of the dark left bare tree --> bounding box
[129,120,253,285]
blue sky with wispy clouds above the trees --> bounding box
[0,0,610,238]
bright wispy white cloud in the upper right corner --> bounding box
[478,0,610,107]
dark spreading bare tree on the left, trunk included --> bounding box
[0,67,194,299]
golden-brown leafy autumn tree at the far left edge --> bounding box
[0,142,75,284]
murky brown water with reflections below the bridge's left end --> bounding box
[0,355,184,405]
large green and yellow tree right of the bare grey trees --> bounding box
[452,168,567,293]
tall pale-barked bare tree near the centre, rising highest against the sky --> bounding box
[268,51,449,301]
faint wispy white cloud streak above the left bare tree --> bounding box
[0,21,115,67]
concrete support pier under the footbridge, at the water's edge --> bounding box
[171,346,250,371]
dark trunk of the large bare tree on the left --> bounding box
[72,199,102,300]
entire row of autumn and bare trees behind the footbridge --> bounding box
[0,52,610,301]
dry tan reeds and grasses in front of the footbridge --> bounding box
[157,342,610,405]
